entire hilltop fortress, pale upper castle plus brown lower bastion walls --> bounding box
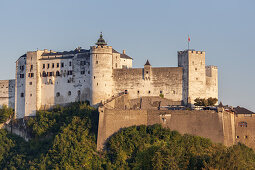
[0,34,255,150]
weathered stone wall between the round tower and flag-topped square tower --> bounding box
[113,67,182,101]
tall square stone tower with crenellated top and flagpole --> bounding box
[178,50,206,104]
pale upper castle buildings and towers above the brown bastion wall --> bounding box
[0,34,218,118]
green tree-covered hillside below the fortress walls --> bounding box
[0,103,255,169]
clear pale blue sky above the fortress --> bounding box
[0,0,255,111]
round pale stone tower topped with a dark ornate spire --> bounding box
[90,33,113,105]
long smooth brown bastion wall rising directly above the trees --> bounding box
[97,107,234,150]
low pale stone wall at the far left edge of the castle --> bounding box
[0,80,15,109]
